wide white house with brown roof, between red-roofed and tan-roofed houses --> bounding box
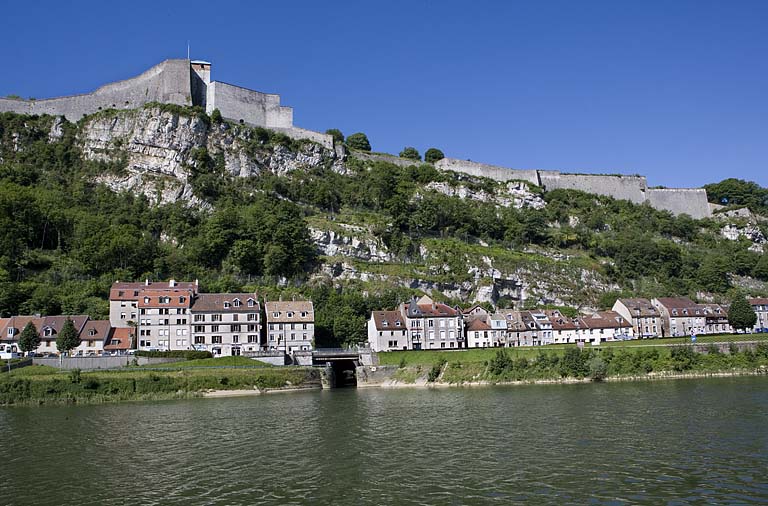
[190,293,264,356]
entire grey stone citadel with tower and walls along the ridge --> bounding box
[0,59,716,218]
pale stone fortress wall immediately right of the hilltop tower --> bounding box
[206,81,293,128]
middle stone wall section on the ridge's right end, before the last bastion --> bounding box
[539,171,648,204]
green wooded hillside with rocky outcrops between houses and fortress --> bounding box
[0,105,768,345]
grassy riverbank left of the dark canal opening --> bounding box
[0,363,320,406]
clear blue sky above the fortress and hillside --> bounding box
[0,0,768,187]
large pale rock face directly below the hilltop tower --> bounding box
[80,108,342,207]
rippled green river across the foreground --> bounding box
[0,378,768,505]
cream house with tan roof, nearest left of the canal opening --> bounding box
[264,300,315,353]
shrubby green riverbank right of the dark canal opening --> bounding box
[380,343,768,384]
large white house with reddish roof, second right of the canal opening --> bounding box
[399,295,467,350]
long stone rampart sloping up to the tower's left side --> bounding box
[0,60,192,121]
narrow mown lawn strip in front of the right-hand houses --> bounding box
[379,334,768,366]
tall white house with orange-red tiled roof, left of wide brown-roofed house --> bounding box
[137,287,195,351]
